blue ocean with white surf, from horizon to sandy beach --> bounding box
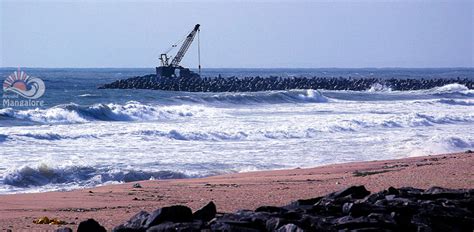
[0,68,474,194]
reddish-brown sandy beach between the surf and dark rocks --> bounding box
[0,152,474,231]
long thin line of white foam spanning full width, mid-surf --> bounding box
[6,113,474,142]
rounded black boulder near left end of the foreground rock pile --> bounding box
[144,205,193,228]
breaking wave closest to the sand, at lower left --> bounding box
[0,163,283,192]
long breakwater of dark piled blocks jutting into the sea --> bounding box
[99,74,474,92]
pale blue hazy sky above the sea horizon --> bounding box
[0,0,474,68]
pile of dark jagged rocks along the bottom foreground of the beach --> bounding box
[63,186,474,232]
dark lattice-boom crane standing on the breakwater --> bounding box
[156,24,201,78]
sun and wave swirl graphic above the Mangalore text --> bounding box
[3,69,45,99]
